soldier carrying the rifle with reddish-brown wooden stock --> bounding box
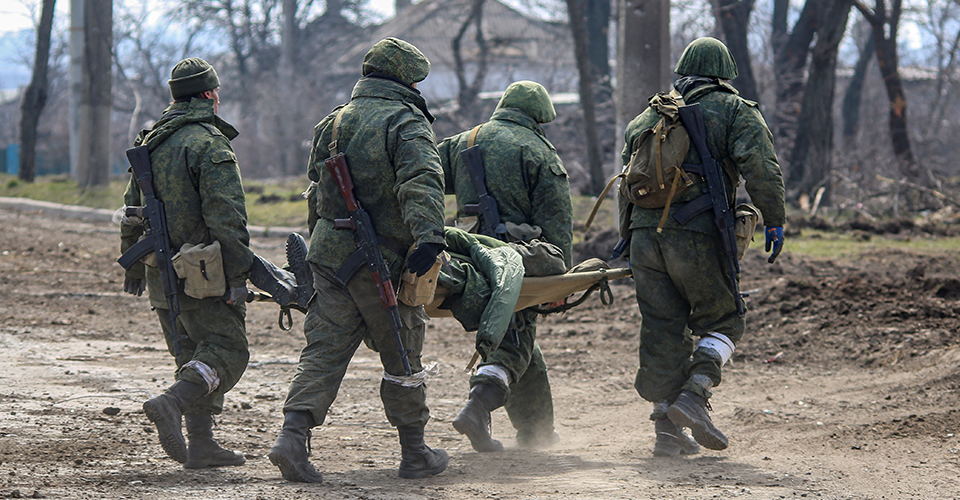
[269,38,448,483]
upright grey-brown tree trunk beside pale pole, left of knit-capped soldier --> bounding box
[77,0,113,187]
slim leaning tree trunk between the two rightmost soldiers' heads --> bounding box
[566,0,606,194]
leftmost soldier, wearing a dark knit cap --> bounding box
[121,58,253,469]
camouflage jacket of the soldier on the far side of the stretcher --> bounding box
[439,108,573,268]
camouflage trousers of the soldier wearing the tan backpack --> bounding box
[630,228,745,402]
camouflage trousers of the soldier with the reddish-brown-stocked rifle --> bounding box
[283,264,430,427]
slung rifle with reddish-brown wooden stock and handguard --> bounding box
[324,153,412,376]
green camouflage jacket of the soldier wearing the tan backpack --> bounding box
[620,80,786,233]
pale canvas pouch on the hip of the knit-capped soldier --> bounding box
[173,241,227,299]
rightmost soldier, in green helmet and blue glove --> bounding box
[620,38,785,456]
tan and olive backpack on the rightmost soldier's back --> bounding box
[585,90,693,232]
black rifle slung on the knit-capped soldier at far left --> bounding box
[117,146,187,357]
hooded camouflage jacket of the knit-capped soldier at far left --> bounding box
[120,99,253,309]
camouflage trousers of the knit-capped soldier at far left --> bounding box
[156,297,250,415]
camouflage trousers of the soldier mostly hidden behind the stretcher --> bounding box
[470,310,554,441]
